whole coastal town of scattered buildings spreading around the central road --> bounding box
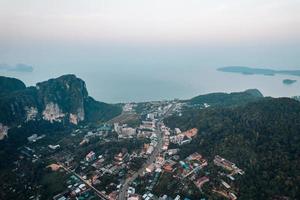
[4,100,245,200]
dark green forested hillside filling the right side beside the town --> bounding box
[165,98,300,199]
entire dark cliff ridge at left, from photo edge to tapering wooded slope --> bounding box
[0,75,121,139]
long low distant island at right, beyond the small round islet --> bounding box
[217,66,300,76]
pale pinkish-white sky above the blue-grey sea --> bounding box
[0,0,300,45]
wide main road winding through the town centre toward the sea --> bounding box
[118,104,175,200]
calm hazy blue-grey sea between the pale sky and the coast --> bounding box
[0,45,300,103]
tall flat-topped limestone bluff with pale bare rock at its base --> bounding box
[36,75,88,124]
